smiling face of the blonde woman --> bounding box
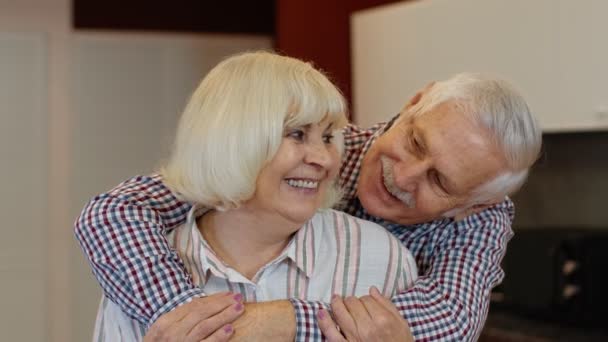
[245,119,340,224]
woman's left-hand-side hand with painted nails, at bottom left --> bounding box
[144,292,244,342]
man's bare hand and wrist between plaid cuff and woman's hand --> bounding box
[231,300,296,342]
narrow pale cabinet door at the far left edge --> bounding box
[0,33,48,341]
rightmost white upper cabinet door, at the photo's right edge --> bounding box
[552,0,608,130]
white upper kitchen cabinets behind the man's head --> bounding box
[351,0,608,132]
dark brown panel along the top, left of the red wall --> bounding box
[72,0,275,35]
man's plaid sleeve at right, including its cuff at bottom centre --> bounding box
[292,200,513,342]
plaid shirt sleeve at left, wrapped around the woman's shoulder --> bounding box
[75,175,204,326]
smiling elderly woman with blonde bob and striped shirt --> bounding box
[95,52,417,341]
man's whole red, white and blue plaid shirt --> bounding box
[75,120,514,341]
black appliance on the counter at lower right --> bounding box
[491,227,608,330]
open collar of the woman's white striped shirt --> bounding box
[179,206,317,283]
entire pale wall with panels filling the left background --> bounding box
[0,0,271,342]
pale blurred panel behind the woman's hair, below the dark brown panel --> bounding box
[69,33,270,341]
